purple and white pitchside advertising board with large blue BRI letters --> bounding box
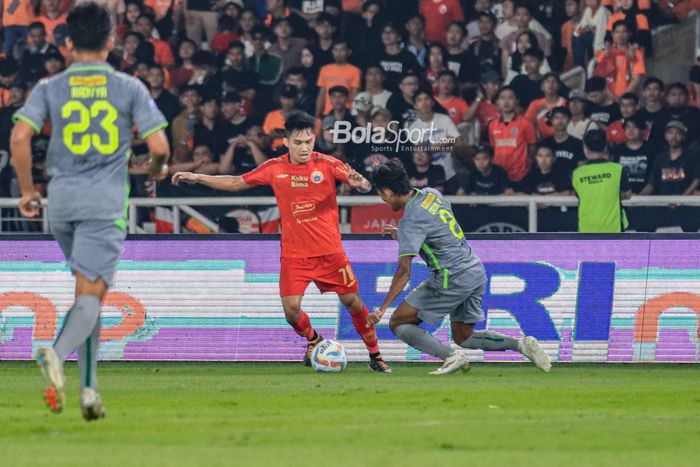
[0,235,700,362]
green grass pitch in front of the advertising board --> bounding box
[0,362,700,467]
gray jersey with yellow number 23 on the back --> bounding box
[14,62,167,227]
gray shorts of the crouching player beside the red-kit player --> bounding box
[406,268,486,324]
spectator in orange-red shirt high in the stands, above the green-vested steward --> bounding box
[593,21,646,97]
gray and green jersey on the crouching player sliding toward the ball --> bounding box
[398,188,481,288]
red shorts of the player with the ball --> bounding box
[280,253,357,297]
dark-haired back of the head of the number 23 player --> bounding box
[66,2,112,52]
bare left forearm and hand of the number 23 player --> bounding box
[10,120,41,217]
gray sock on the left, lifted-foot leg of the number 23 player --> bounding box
[53,295,100,361]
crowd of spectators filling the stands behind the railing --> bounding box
[0,0,700,230]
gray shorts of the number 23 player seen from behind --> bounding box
[51,220,126,288]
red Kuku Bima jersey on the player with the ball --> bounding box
[243,152,349,258]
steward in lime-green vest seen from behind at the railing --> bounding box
[571,130,632,233]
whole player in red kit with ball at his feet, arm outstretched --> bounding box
[172,112,391,372]
